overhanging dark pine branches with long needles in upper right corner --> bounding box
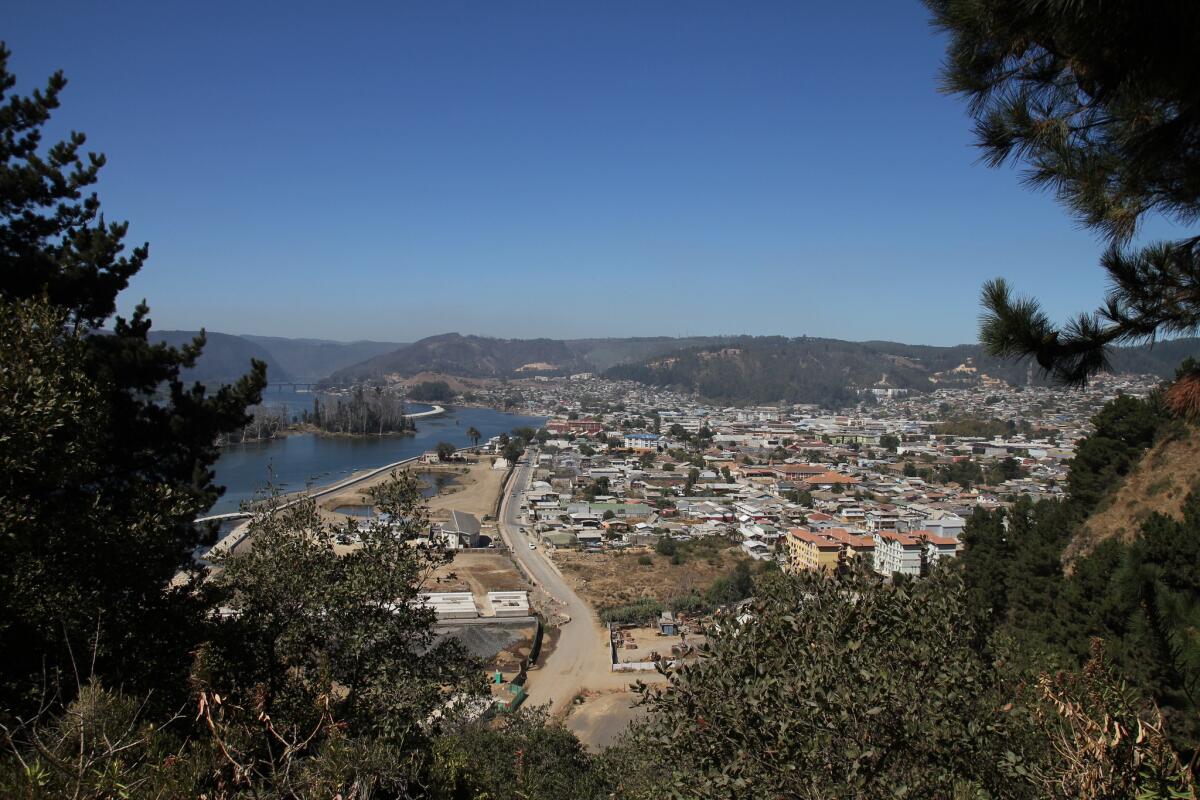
[925,0,1200,414]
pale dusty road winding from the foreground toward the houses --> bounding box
[499,450,629,712]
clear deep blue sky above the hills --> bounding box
[0,0,1176,344]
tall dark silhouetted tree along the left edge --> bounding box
[0,46,266,709]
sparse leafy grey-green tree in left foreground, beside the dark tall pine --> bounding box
[193,473,482,796]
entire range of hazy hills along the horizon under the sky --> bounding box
[151,331,1200,405]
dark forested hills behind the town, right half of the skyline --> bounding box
[605,336,1200,405]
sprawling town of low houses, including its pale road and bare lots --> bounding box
[352,374,1159,747]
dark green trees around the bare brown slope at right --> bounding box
[960,398,1200,760]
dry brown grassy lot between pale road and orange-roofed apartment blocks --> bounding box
[553,540,745,608]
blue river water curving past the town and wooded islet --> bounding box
[210,392,546,513]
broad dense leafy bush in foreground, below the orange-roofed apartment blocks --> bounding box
[618,572,1021,798]
